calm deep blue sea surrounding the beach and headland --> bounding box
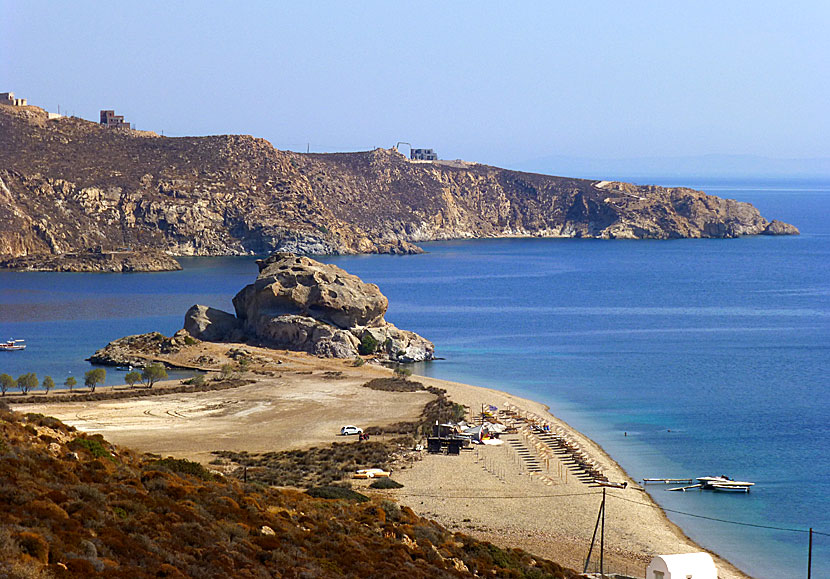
[0,180,830,578]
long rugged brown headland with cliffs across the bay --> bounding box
[0,106,797,256]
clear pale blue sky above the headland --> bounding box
[0,0,830,174]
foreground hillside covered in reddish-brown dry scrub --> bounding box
[0,408,577,579]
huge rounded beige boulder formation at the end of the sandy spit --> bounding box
[185,253,434,362]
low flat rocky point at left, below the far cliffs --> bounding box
[0,251,182,273]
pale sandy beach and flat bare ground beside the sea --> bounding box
[13,343,747,578]
